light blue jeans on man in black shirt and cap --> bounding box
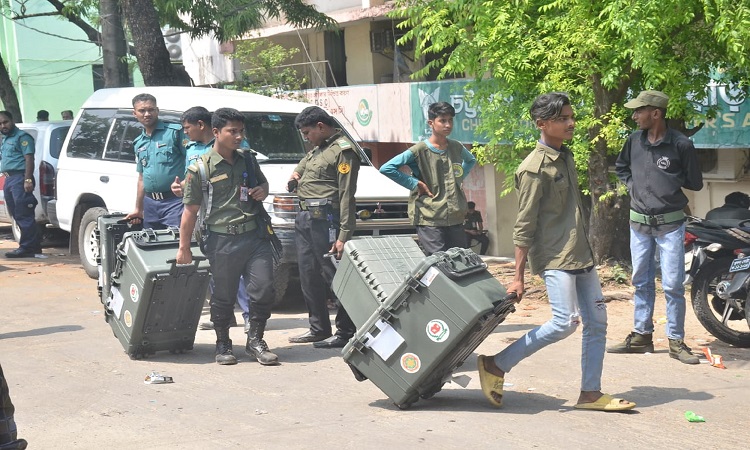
[630,223,685,339]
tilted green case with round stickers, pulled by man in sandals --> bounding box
[336,241,515,409]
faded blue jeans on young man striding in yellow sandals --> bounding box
[494,269,607,391]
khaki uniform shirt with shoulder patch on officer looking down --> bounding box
[294,130,360,242]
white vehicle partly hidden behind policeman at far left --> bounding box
[0,120,72,242]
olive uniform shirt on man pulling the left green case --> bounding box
[182,150,267,225]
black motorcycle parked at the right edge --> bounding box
[685,217,750,347]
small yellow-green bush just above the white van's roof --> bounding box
[233,39,306,96]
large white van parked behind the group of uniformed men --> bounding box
[53,87,414,299]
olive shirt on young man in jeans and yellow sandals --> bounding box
[513,142,594,274]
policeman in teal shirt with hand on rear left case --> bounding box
[125,94,188,229]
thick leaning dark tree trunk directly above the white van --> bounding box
[122,0,185,86]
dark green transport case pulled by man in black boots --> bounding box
[105,228,209,359]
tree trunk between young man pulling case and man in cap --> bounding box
[589,77,630,263]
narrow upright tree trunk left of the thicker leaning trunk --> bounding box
[99,0,130,88]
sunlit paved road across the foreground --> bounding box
[0,229,750,449]
